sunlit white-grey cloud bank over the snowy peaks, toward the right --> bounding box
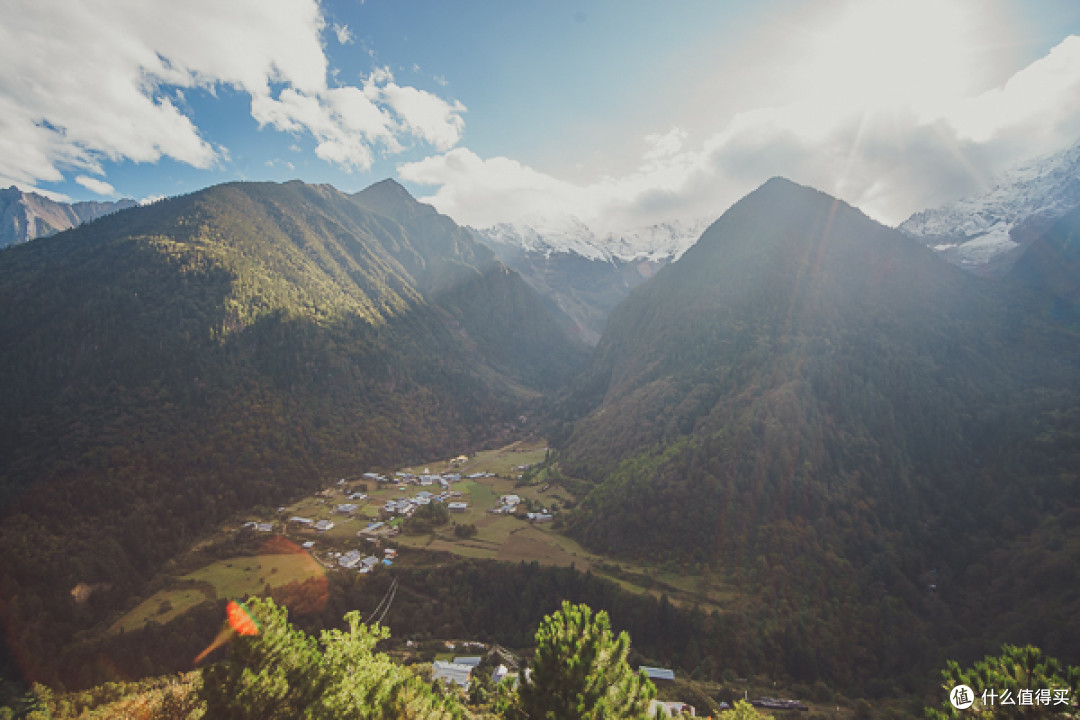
[399,9,1080,232]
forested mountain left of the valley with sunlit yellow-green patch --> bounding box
[0,182,584,679]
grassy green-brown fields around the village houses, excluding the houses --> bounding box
[112,443,735,631]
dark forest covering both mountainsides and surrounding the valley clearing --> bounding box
[0,174,1080,697]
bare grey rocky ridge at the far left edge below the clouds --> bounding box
[0,186,138,247]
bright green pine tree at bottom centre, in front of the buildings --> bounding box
[518,601,656,720]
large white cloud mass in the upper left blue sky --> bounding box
[0,0,464,186]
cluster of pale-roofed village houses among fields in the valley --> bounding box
[226,443,574,587]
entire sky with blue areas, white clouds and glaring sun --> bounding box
[0,0,1080,230]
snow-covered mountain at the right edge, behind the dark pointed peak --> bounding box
[899,142,1080,275]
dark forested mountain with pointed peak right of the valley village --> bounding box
[562,178,1080,682]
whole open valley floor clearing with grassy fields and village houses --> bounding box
[110,440,735,633]
